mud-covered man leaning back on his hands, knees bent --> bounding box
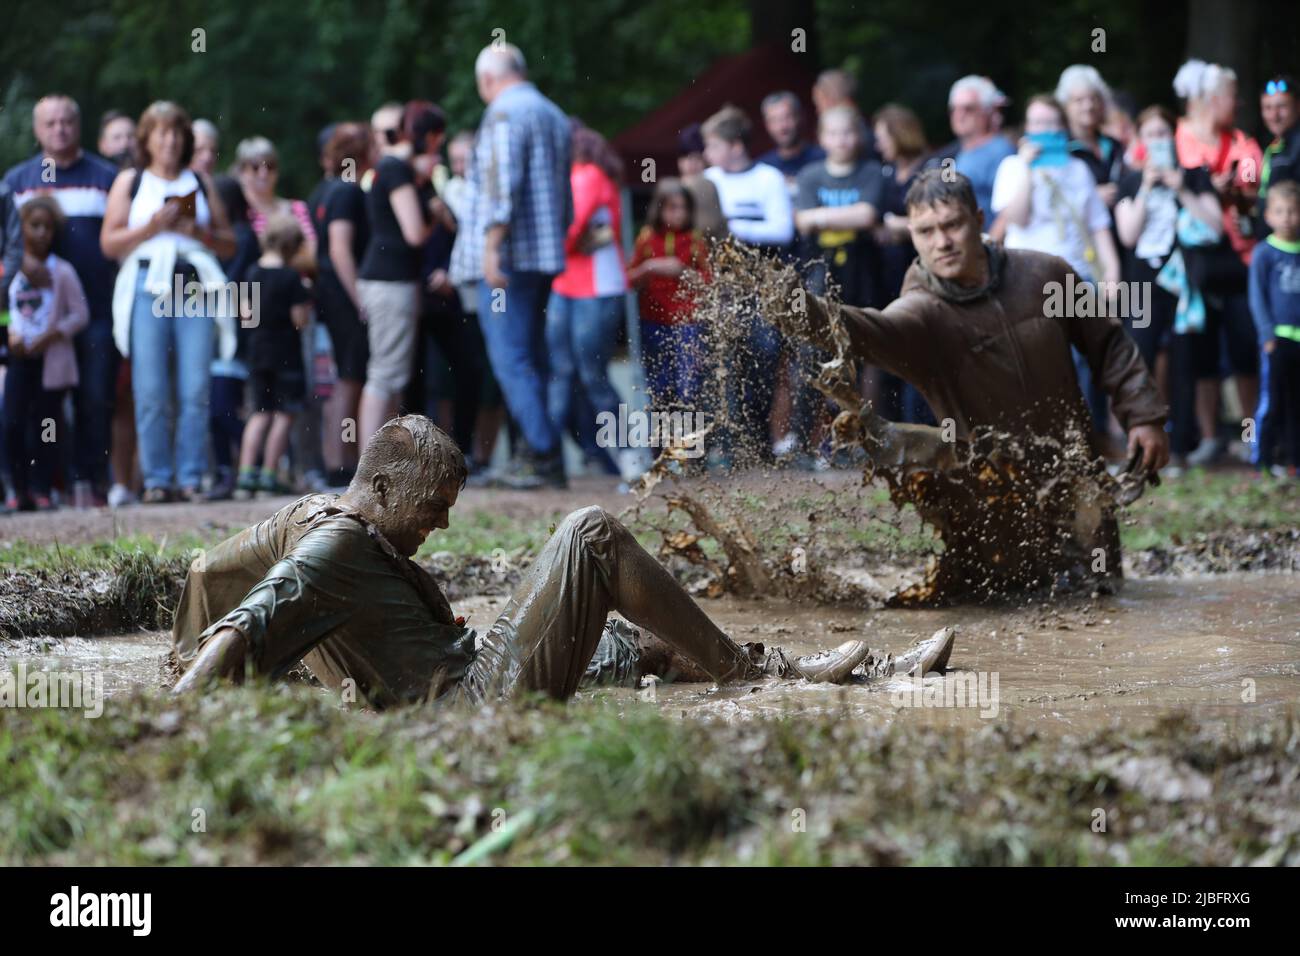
[173,415,953,708]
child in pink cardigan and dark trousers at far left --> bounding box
[4,196,90,511]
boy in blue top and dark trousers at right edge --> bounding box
[1249,182,1300,477]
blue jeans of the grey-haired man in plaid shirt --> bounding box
[478,272,560,457]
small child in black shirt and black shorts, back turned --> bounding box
[234,215,311,499]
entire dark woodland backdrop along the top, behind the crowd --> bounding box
[0,0,1300,196]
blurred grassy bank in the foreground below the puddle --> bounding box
[0,685,1300,865]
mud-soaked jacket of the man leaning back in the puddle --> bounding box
[172,494,475,708]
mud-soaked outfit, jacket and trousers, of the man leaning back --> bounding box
[174,496,749,708]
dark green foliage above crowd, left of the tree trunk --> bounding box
[0,0,749,196]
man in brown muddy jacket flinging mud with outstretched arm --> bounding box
[772,169,1169,604]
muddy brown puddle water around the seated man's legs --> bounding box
[0,574,1300,732]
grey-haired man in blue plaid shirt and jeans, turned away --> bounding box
[451,43,573,488]
